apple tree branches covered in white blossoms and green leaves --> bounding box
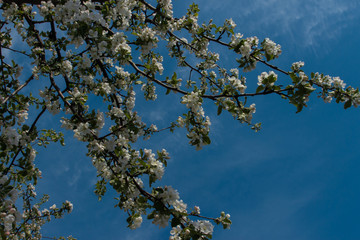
[0,0,360,240]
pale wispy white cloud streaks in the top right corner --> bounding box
[198,0,360,47]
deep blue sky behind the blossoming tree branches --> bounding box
[27,0,360,240]
